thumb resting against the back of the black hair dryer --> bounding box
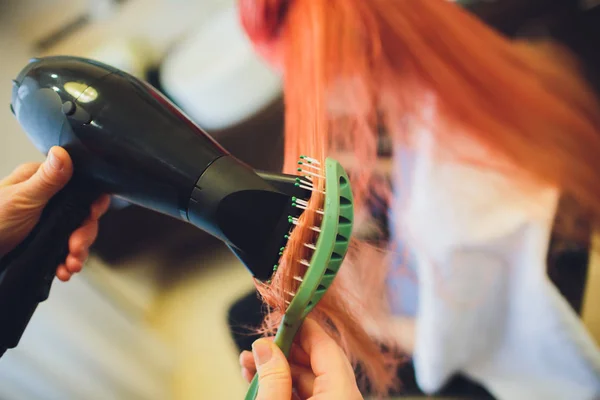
[21,147,73,206]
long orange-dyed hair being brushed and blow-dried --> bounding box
[239,0,600,394]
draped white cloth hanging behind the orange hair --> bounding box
[393,132,600,400]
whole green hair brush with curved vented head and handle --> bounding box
[246,156,354,400]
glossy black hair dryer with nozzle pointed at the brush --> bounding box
[0,57,306,355]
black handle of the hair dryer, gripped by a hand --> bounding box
[0,179,100,356]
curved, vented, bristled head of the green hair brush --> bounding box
[276,156,354,320]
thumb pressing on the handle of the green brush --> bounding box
[252,339,292,400]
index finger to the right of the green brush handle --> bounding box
[299,319,356,389]
